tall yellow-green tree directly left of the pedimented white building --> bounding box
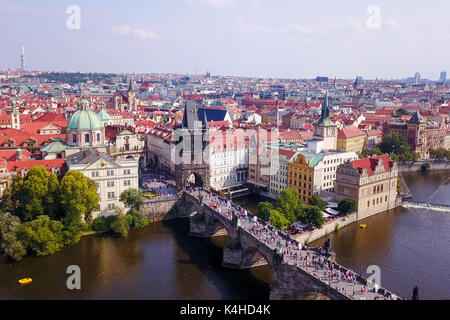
[60,171,100,244]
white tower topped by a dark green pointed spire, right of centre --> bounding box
[313,91,338,150]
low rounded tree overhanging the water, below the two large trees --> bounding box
[19,215,64,256]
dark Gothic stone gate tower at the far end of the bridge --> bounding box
[174,100,210,191]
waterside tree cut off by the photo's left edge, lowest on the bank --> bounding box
[0,212,27,261]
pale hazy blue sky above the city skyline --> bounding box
[0,0,450,80]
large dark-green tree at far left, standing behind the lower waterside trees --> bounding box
[1,167,61,222]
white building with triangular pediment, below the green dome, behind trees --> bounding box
[66,149,139,218]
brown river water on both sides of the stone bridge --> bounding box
[0,172,450,300]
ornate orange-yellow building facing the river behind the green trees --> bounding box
[288,153,323,203]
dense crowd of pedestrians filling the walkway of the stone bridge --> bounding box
[187,185,397,300]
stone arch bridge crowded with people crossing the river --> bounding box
[176,191,402,300]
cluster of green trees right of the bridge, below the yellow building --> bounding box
[258,188,326,230]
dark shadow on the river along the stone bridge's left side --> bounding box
[162,218,272,300]
